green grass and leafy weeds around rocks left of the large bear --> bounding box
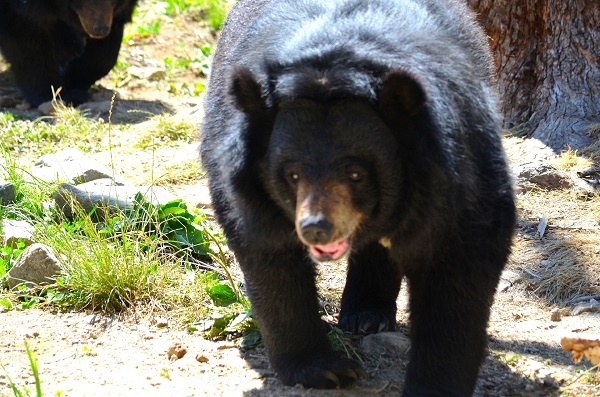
[0,142,249,332]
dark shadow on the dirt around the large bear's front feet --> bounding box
[236,332,573,397]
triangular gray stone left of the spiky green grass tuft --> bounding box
[6,243,63,288]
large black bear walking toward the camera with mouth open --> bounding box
[200,0,515,396]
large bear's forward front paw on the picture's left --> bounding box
[273,356,367,389]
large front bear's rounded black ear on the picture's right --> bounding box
[378,71,427,118]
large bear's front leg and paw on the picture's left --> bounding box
[236,247,365,388]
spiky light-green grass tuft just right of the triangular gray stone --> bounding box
[43,207,164,312]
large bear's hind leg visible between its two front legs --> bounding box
[338,243,402,334]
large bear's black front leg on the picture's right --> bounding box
[404,258,501,397]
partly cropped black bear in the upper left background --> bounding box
[0,0,137,106]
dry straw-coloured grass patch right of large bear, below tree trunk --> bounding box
[511,186,600,305]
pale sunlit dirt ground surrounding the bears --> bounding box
[0,3,600,397]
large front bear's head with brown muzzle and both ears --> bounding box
[231,68,426,261]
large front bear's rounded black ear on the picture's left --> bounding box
[229,66,266,114]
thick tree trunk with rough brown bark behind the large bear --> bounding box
[467,0,600,149]
